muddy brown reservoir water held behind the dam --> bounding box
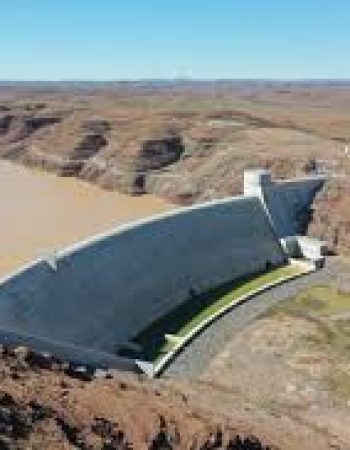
[0,160,173,276]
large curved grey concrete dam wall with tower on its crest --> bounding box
[0,171,324,370]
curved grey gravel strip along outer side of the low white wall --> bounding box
[162,258,344,378]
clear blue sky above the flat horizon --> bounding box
[0,0,350,80]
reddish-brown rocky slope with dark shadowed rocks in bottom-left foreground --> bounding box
[0,347,284,450]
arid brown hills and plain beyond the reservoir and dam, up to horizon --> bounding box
[0,82,350,252]
